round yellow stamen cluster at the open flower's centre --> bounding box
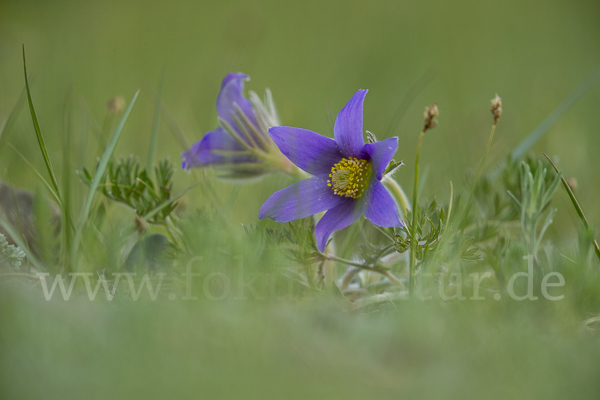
[327,157,371,199]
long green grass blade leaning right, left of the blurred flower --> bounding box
[70,89,140,262]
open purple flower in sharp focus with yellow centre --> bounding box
[258,90,403,251]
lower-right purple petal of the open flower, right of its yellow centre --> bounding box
[360,179,404,228]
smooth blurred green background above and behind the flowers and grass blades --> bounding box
[0,0,600,234]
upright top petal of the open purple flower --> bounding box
[333,90,367,158]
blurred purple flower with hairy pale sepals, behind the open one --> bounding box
[181,73,299,178]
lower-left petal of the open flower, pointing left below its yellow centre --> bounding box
[258,175,345,222]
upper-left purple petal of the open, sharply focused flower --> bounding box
[269,126,344,175]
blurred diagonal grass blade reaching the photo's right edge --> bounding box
[512,67,600,160]
